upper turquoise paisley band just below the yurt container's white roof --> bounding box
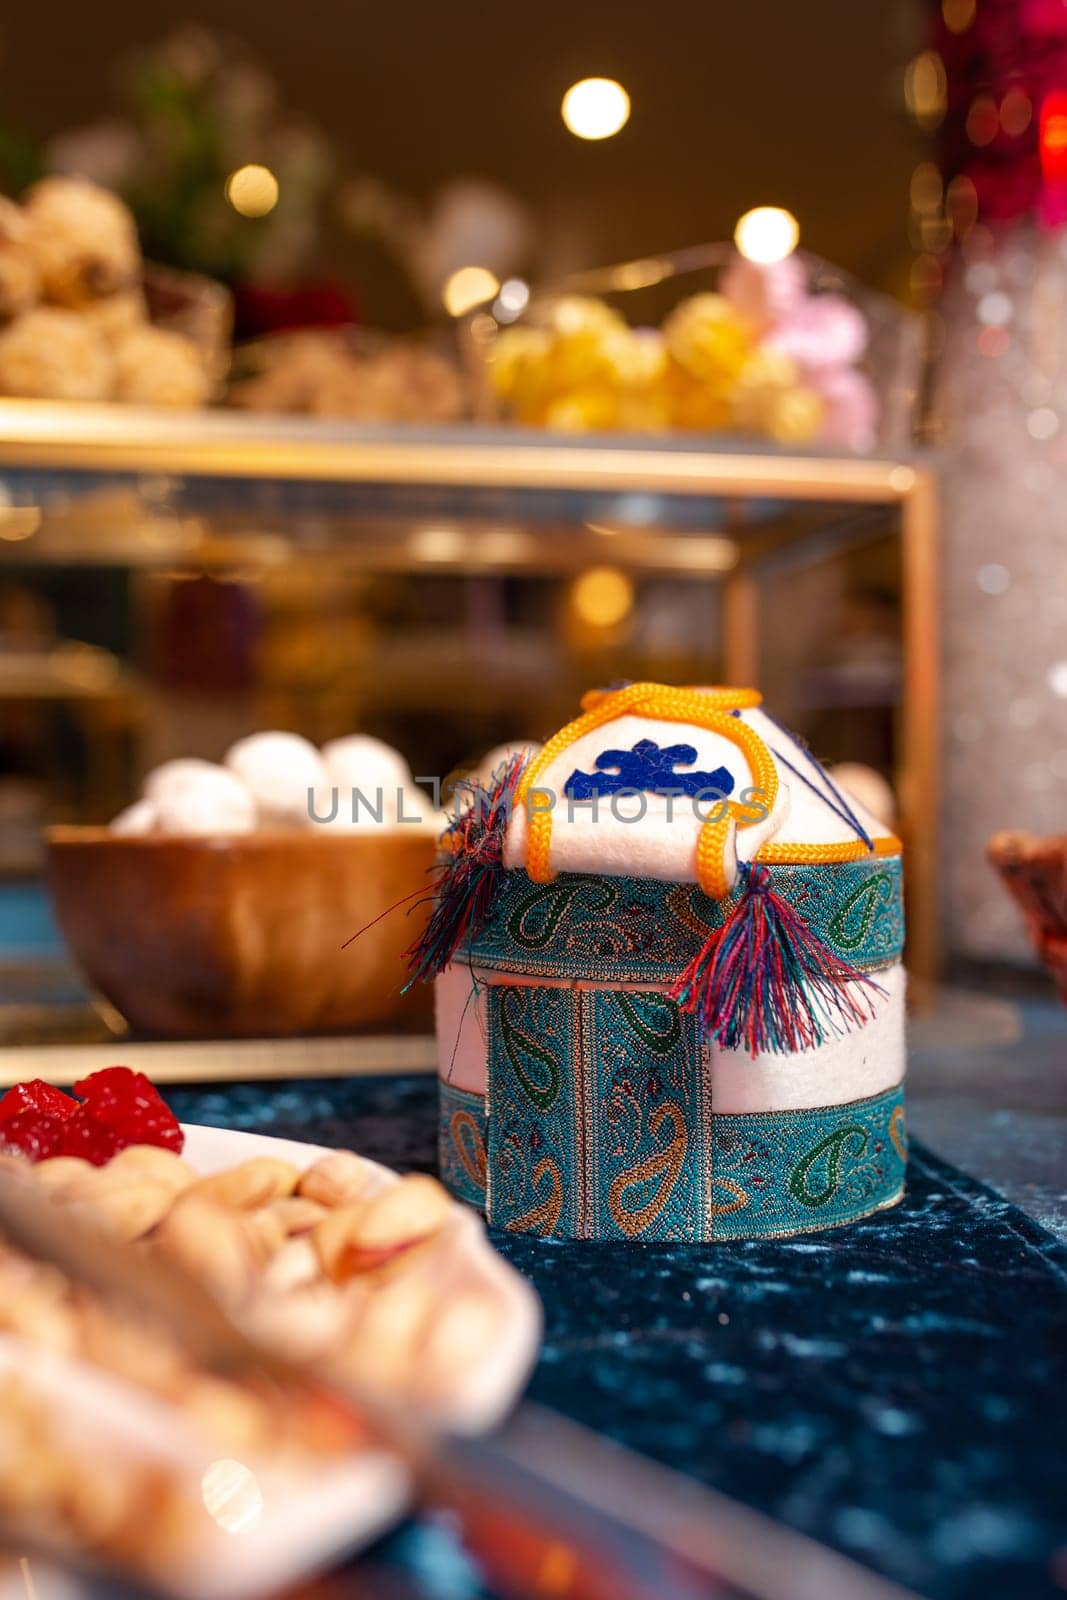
[467,856,904,982]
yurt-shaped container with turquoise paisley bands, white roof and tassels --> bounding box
[414,683,907,1242]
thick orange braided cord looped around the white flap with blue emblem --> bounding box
[515,683,777,899]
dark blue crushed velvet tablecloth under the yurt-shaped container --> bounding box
[168,1077,1067,1600]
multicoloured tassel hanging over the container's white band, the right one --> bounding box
[669,866,885,1056]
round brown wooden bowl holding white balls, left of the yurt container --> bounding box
[48,827,435,1038]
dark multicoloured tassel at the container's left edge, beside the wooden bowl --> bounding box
[405,755,525,989]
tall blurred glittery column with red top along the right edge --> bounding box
[934,0,1067,962]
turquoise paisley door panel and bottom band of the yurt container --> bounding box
[440,984,907,1243]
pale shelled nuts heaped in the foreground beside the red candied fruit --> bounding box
[0,1146,504,1408]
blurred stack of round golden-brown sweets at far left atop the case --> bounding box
[0,178,213,406]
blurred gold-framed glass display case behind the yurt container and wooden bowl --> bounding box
[0,402,939,1062]
